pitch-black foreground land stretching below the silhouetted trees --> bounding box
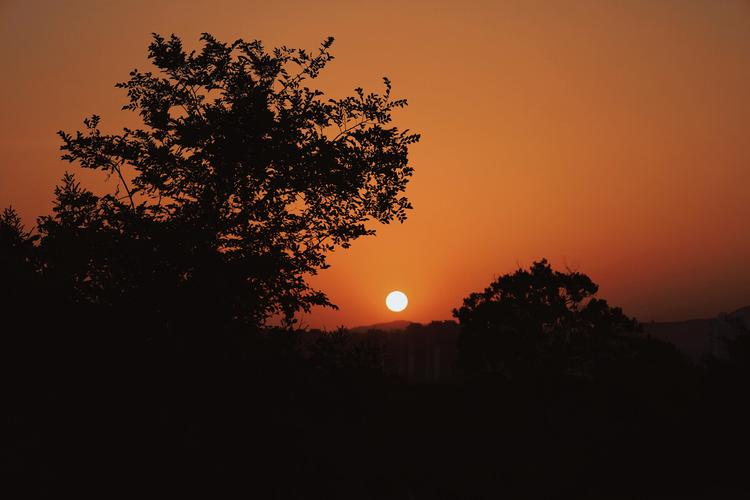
[3,308,750,500]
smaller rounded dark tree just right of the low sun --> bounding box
[453,259,639,376]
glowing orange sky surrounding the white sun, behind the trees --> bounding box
[0,0,750,328]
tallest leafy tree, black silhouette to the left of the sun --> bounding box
[44,34,419,325]
